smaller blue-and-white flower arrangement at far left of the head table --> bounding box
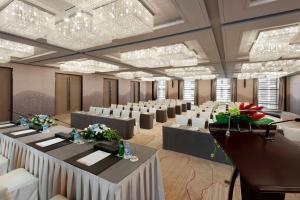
[29,114,55,131]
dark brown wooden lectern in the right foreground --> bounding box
[210,125,300,200]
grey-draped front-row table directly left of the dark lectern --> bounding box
[163,123,230,164]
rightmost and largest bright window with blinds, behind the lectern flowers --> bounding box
[257,78,279,109]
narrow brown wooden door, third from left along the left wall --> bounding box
[103,78,118,107]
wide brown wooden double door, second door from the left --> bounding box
[55,73,82,115]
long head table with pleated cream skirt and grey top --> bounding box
[0,126,164,200]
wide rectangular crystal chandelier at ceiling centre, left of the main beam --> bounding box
[121,44,198,68]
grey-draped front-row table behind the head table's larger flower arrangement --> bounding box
[71,111,135,140]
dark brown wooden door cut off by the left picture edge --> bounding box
[0,67,12,122]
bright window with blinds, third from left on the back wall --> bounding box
[216,78,231,102]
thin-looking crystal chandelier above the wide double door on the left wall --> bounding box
[59,60,119,73]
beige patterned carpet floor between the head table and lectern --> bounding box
[58,115,300,200]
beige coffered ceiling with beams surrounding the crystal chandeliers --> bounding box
[0,0,300,77]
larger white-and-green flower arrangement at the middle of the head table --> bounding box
[81,124,121,142]
